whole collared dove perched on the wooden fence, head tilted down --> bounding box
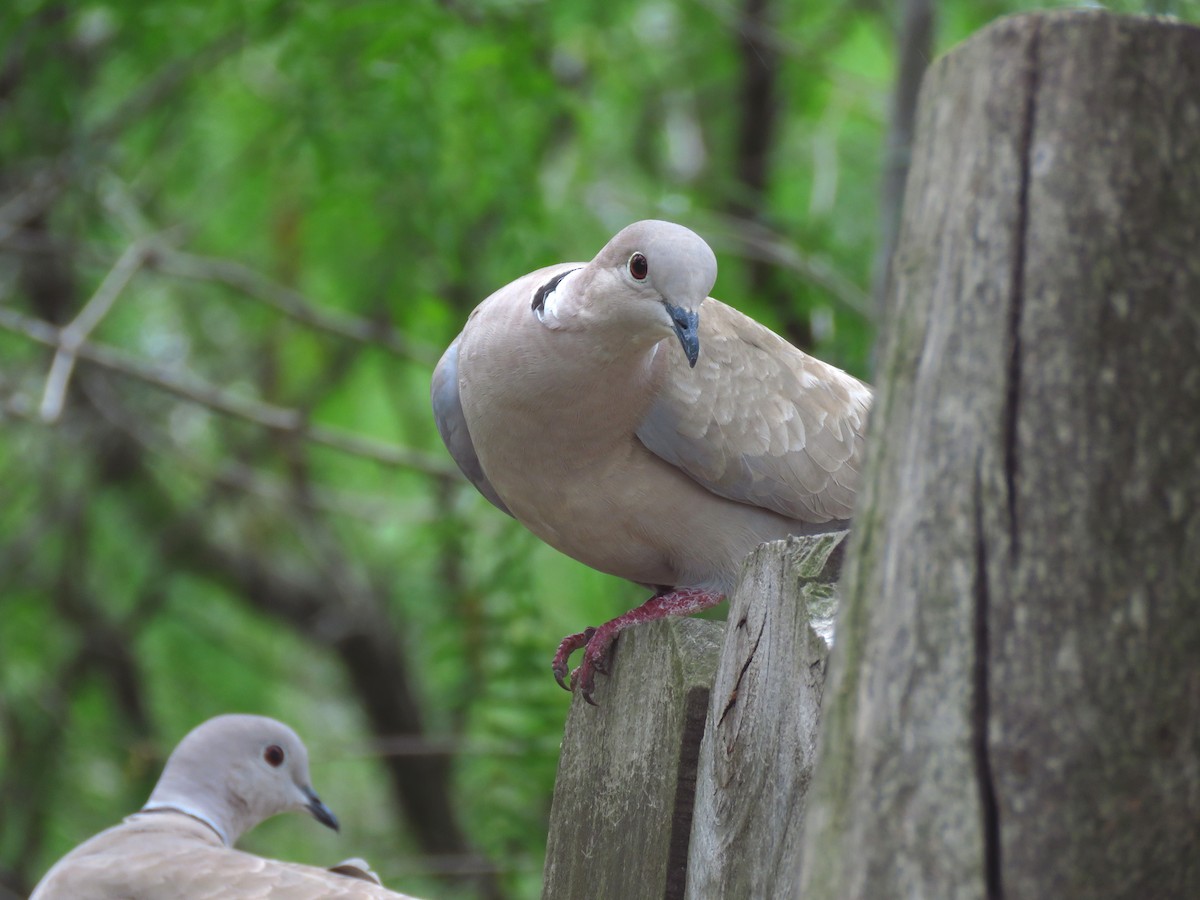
[432,221,871,701]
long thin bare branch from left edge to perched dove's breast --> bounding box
[0,306,457,478]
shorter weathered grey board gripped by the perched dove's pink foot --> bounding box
[541,618,725,900]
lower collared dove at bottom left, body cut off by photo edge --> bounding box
[30,715,420,900]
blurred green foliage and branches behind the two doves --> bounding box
[0,0,1200,898]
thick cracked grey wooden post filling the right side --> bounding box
[802,12,1200,898]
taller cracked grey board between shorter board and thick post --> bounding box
[686,532,846,900]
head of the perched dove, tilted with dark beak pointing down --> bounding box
[588,220,716,366]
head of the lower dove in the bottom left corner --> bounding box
[143,715,337,846]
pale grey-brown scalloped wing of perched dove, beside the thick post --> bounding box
[637,299,871,524]
